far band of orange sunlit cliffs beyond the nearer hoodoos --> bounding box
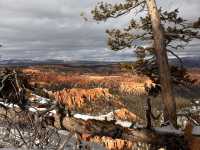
[22,68,153,95]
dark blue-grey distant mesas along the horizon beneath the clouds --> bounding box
[0,56,200,68]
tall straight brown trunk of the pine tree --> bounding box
[146,0,177,127]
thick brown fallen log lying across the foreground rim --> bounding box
[62,117,192,150]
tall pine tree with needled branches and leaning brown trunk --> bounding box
[91,0,200,126]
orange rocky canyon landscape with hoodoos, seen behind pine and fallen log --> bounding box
[0,65,200,149]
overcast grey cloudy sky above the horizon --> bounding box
[0,0,200,61]
